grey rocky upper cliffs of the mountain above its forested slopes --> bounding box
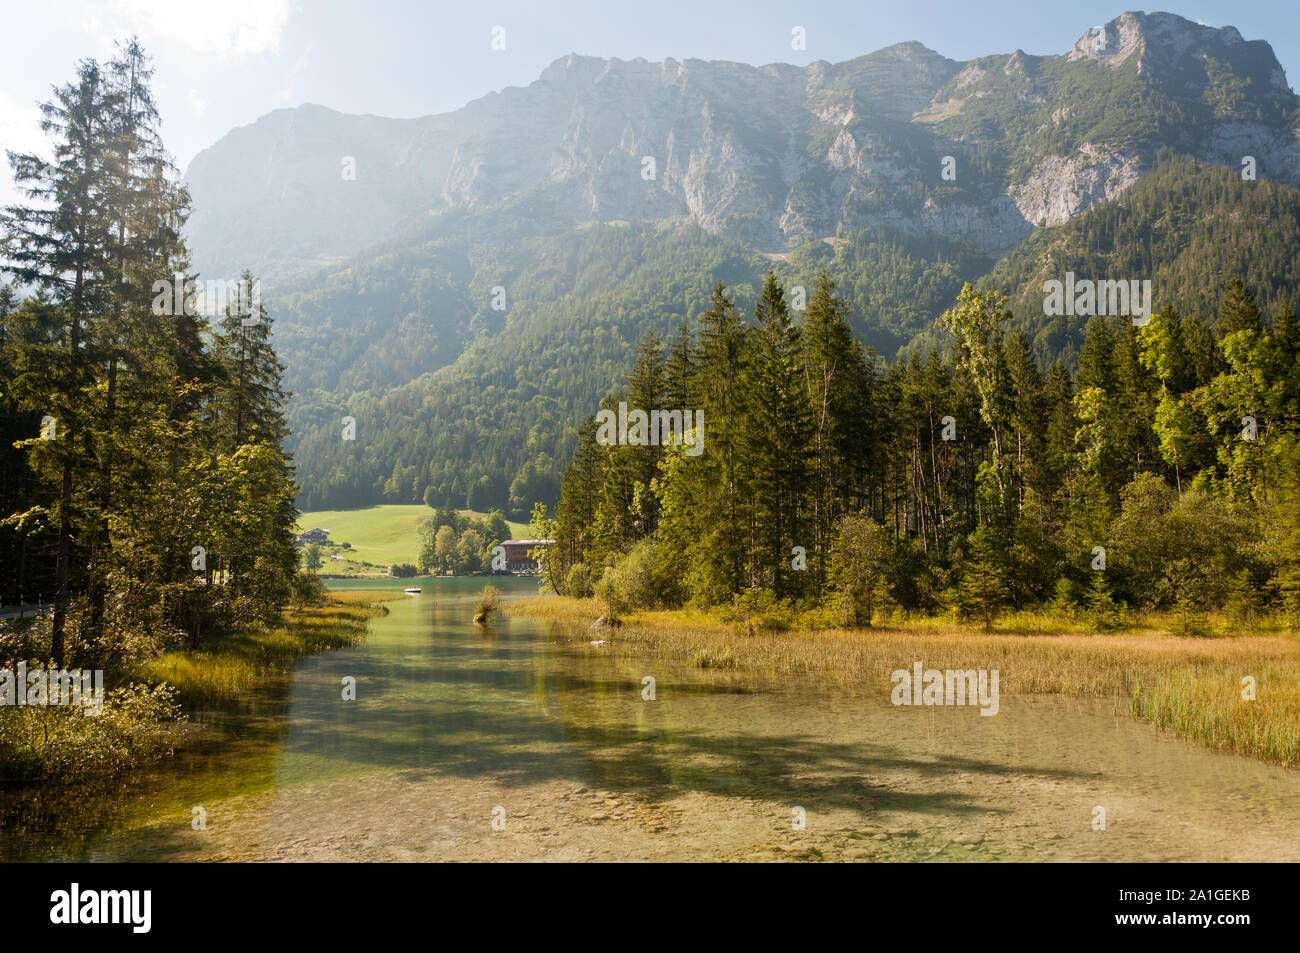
[189,13,1300,280]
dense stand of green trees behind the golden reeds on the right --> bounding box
[547,273,1300,629]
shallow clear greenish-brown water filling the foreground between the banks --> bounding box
[0,580,1300,861]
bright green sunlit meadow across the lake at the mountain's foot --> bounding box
[298,503,528,575]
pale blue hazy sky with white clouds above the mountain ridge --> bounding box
[0,0,1300,200]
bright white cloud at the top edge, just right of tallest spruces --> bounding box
[82,0,294,59]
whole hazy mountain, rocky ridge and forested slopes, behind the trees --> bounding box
[186,13,1300,515]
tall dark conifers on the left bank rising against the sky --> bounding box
[0,42,296,670]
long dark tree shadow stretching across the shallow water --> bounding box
[282,705,1082,813]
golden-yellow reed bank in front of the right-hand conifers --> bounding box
[508,595,1300,767]
